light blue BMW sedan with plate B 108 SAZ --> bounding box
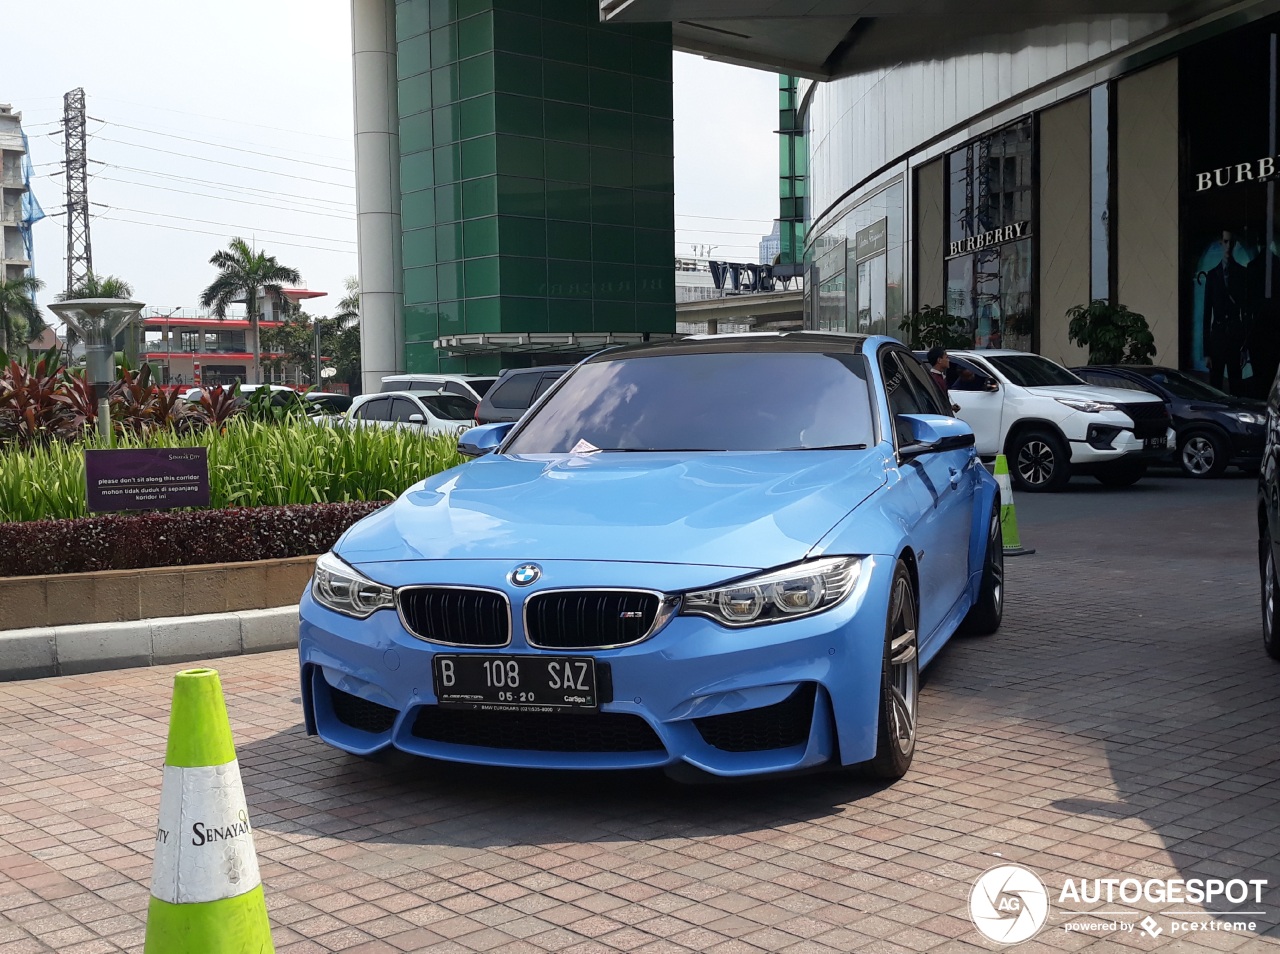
[298,333,1004,779]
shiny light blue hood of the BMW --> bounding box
[334,449,886,569]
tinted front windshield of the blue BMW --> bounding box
[507,351,873,453]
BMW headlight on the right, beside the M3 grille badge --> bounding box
[680,557,863,626]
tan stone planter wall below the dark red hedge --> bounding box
[0,556,316,630]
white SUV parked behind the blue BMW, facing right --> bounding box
[931,350,1175,492]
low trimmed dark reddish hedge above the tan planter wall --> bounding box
[0,501,387,576]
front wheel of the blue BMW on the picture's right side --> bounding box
[865,560,920,781]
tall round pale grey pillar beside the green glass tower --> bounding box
[351,0,404,393]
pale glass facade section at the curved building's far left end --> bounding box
[805,181,905,337]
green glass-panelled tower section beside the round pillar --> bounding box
[396,0,675,371]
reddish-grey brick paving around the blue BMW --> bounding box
[0,478,1280,954]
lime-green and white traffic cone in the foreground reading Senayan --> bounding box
[143,670,275,954]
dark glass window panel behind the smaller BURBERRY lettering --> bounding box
[946,117,1036,351]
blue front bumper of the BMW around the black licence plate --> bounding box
[298,557,893,776]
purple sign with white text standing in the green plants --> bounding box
[84,447,209,512]
